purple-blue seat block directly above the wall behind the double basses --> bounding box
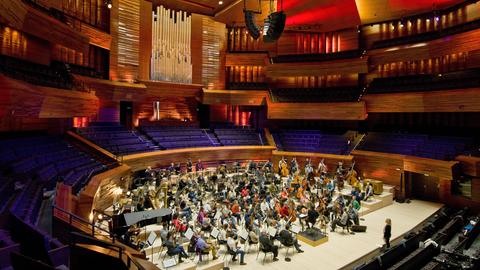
[272,130,350,155]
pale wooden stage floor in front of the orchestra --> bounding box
[147,200,442,270]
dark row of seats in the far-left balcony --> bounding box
[0,55,73,89]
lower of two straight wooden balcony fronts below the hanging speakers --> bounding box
[267,101,367,120]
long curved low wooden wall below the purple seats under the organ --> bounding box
[123,146,274,171]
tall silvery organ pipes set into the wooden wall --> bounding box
[150,6,192,83]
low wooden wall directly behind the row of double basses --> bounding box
[272,150,353,172]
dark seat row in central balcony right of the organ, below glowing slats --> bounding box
[271,86,362,103]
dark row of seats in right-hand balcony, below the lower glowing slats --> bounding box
[367,69,480,94]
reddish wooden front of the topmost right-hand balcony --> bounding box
[368,29,480,65]
